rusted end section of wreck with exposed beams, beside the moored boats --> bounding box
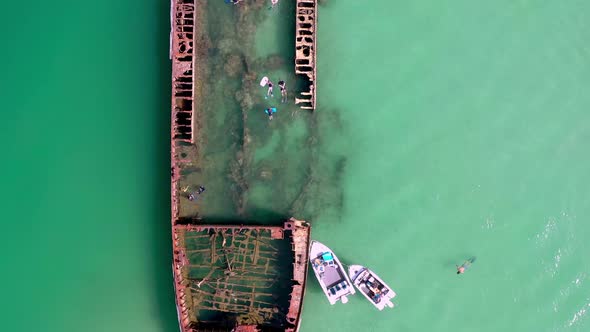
[173,218,310,332]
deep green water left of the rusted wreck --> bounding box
[0,1,177,332]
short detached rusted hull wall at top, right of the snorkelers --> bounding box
[295,0,318,110]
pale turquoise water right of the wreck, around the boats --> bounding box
[303,1,590,331]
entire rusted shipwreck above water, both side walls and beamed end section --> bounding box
[170,0,316,332]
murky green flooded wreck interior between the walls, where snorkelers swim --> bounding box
[179,1,328,222]
